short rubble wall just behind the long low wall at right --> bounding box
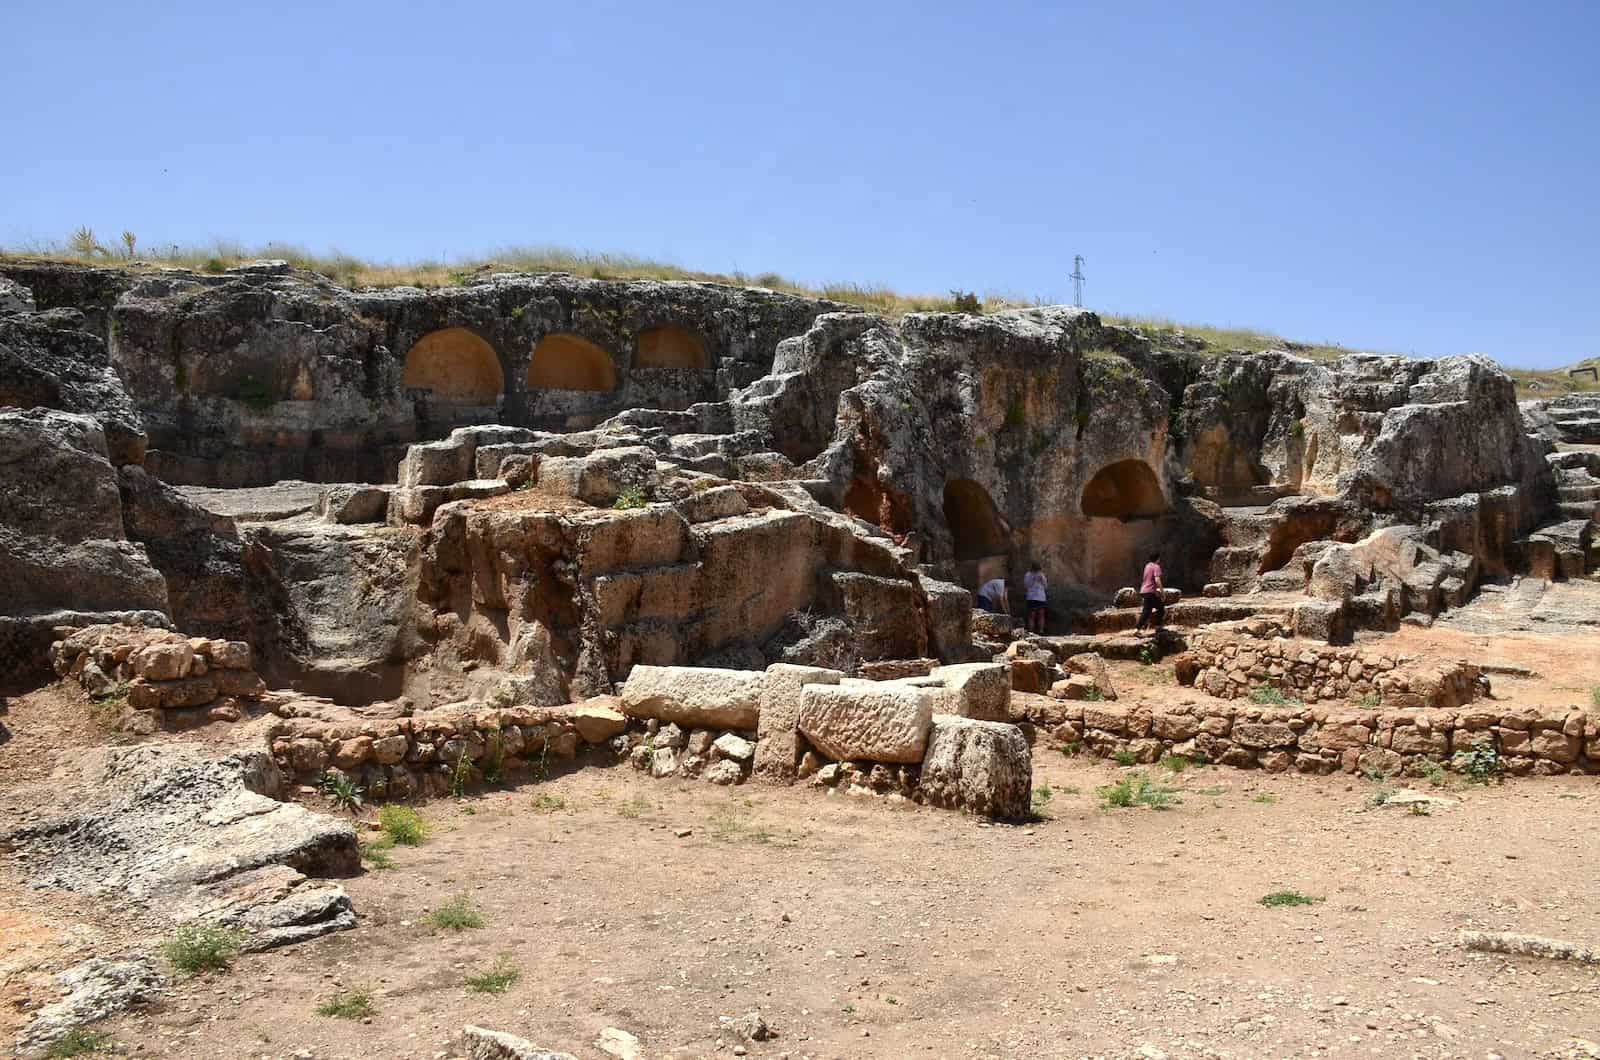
[1174,631,1488,709]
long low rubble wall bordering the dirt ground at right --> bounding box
[1011,695,1600,777]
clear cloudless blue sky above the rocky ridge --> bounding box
[0,0,1600,365]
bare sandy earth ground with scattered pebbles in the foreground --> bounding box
[10,749,1600,1058]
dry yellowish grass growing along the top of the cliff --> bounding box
[9,227,1600,384]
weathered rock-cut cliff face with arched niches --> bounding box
[0,261,1574,703]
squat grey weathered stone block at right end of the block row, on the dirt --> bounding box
[917,714,1034,820]
